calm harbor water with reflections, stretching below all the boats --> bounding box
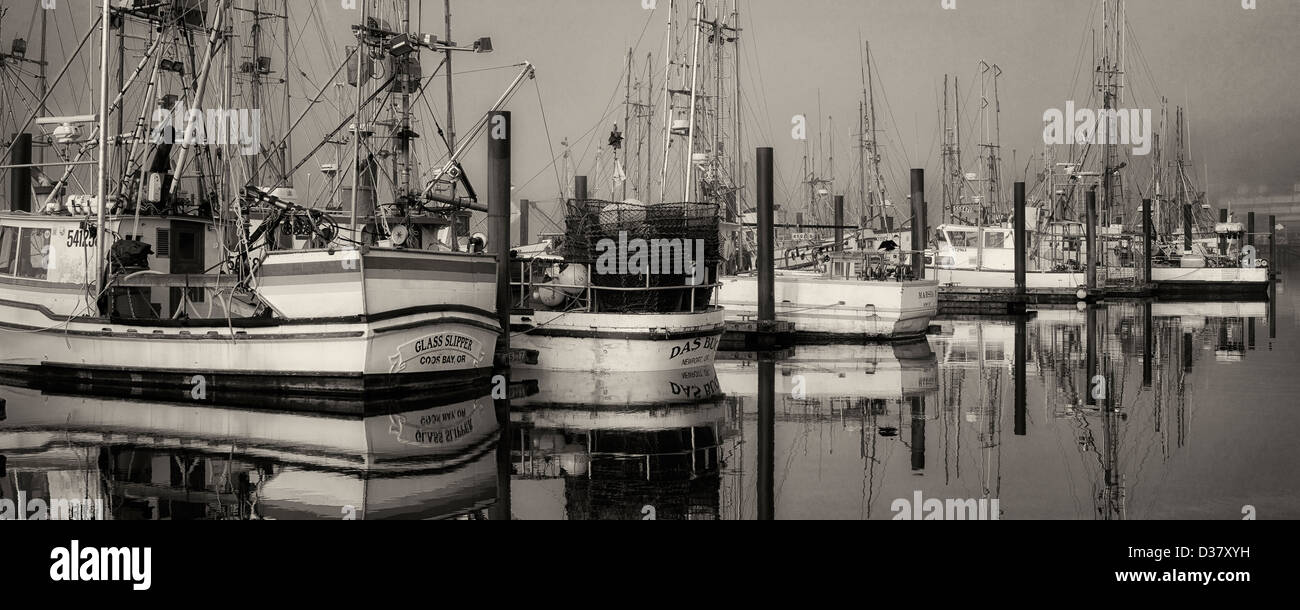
[0,261,1300,519]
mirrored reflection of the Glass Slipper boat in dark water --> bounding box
[0,386,501,519]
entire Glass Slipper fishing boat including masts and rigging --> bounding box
[0,0,532,401]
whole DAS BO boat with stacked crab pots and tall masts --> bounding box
[511,0,737,372]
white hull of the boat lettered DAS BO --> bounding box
[510,308,725,372]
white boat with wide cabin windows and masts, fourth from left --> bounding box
[927,55,1141,300]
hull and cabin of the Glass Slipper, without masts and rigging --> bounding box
[0,213,501,397]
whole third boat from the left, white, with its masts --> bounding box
[714,35,939,342]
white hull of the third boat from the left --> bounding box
[719,272,939,341]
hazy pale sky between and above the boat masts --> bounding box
[0,0,1300,228]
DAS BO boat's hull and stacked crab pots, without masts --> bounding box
[511,200,725,372]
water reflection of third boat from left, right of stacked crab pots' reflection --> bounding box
[718,341,939,519]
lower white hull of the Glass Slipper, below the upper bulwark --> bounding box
[0,300,499,403]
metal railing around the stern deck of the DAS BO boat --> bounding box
[510,256,722,313]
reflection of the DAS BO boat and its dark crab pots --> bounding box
[508,365,728,520]
